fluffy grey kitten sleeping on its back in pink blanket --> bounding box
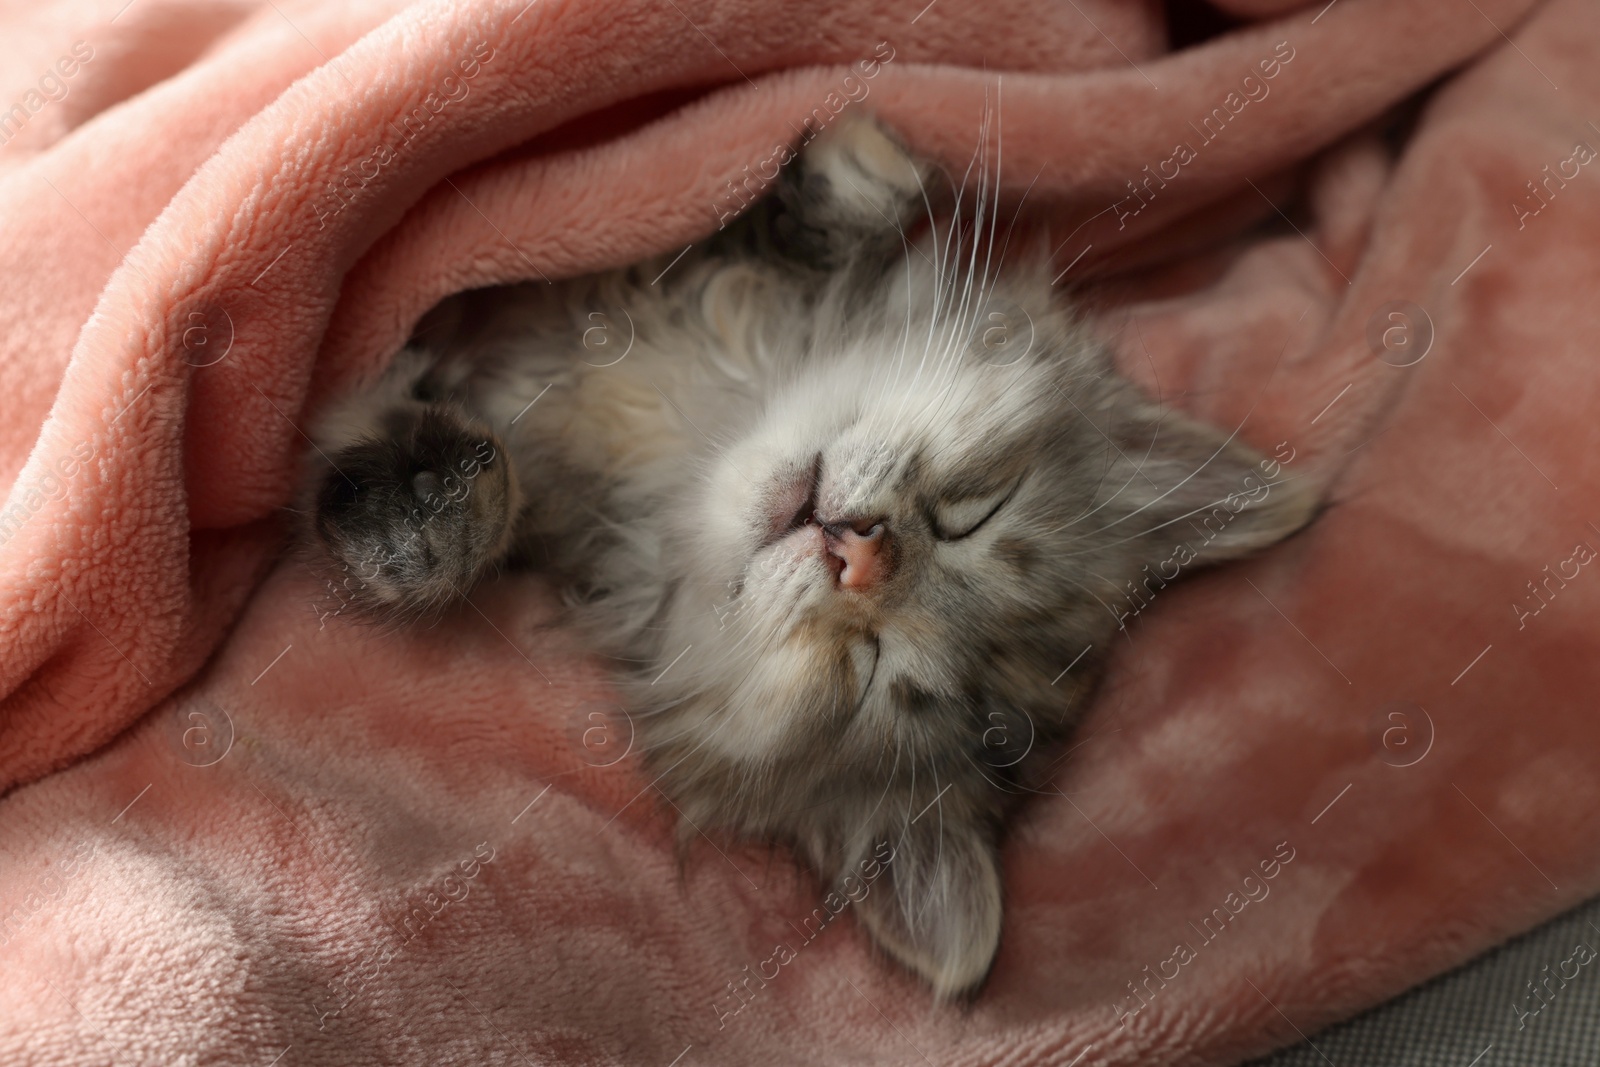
[306,120,1314,997]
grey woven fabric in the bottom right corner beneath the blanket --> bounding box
[1251,899,1600,1067]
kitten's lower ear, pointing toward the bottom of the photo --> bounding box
[840,805,1002,997]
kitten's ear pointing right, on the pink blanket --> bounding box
[1102,400,1317,568]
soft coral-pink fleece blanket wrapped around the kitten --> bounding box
[0,0,1600,1067]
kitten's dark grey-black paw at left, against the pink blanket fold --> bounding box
[314,406,517,617]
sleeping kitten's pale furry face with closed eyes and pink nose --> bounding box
[662,319,1104,763]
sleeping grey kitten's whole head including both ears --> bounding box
[650,262,1312,995]
